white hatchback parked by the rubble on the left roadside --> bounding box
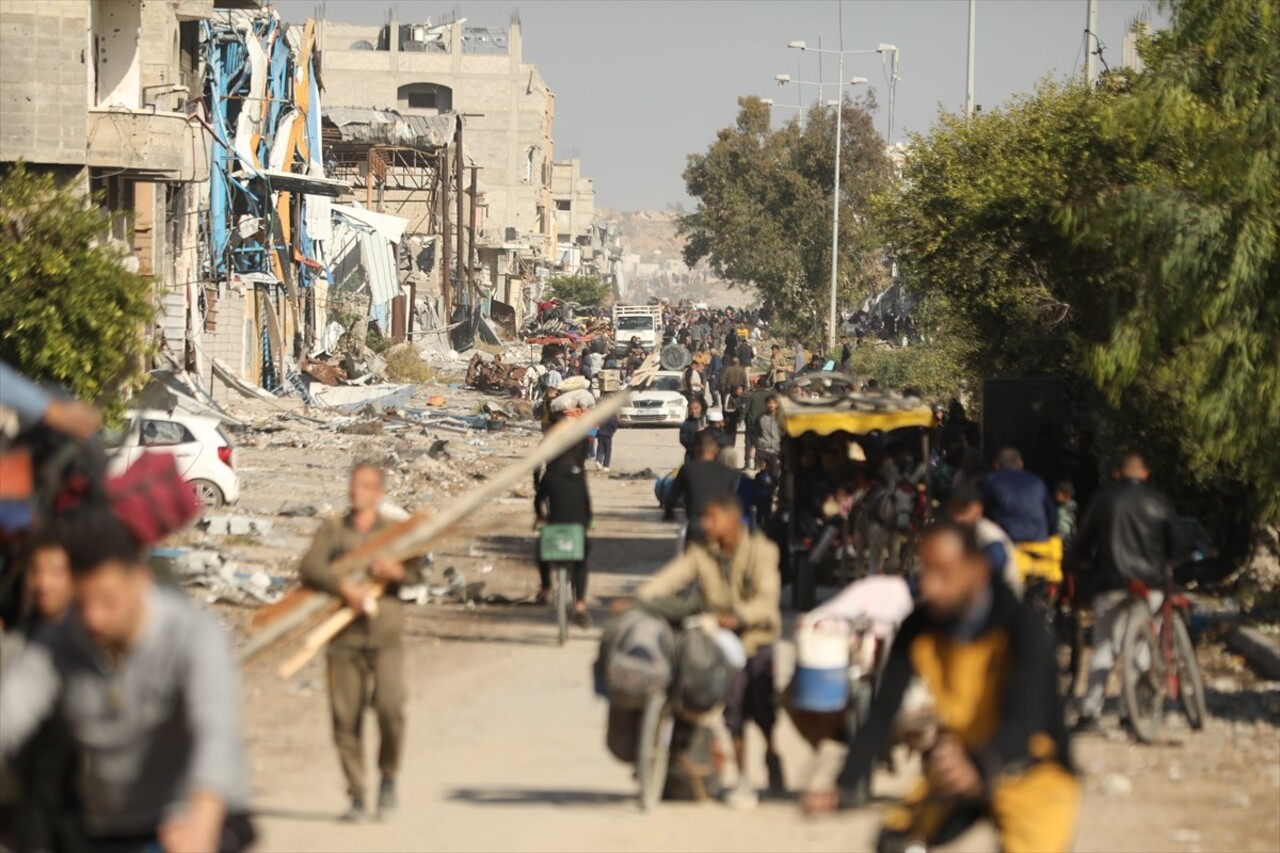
[104,409,239,510]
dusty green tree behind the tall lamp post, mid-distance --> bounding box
[678,97,892,337]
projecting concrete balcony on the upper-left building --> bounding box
[84,108,212,183]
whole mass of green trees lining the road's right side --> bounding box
[877,0,1280,530]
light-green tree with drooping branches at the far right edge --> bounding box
[1061,0,1280,523]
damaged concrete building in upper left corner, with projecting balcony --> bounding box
[0,0,225,360]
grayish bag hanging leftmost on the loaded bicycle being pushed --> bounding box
[595,607,675,710]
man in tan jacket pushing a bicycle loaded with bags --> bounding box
[636,491,783,808]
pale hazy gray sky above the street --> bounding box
[275,0,1160,210]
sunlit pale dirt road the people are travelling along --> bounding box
[238,430,1280,850]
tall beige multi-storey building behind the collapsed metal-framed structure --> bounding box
[317,13,594,335]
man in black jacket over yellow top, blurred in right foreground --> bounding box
[805,520,1080,852]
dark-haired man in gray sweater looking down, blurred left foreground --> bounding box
[0,511,253,850]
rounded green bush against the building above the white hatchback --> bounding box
[0,163,154,407]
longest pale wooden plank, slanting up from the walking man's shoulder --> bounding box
[241,392,631,662]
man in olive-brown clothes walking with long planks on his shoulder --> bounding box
[298,462,421,822]
